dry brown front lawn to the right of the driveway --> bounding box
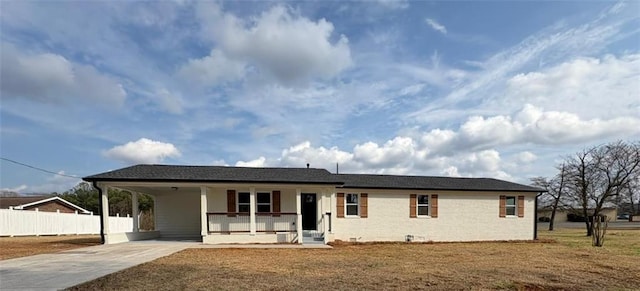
[74,230,640,290]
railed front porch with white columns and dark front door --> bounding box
[201,186,335,244]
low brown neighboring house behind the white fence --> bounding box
[0,196,91,214]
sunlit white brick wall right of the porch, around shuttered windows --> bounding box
[329,189,535,241]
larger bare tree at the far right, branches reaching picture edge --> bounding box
[565,141,640,236]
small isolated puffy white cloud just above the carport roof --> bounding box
[104,138,181,164]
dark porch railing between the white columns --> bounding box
[207,212,297,233]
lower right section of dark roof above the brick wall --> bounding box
[336,174,545,192]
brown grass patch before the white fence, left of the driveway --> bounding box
[0,235,100,260]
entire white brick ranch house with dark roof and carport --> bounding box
[83,165,544,244]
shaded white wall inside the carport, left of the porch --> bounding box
[155,189,200,238]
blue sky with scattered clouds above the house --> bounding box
[0,0,640,193]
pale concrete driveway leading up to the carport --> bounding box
[0,241,195,290]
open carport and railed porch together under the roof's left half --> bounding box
[100,182,335,244]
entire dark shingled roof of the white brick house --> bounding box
[83,165,544,192]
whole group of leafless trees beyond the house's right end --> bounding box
[532,141,640,236]
